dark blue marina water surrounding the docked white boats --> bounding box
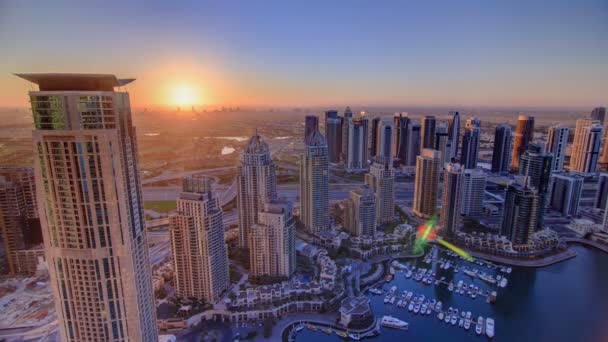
[296,246,608,342]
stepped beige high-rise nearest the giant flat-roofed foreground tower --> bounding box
[169,175,230,303]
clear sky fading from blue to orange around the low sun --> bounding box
[0,0,608,107]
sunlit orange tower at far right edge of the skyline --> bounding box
[570,118,603,173]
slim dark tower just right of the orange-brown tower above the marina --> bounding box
[439,163,463,236]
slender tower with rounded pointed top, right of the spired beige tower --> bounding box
[300,130,329,234]
